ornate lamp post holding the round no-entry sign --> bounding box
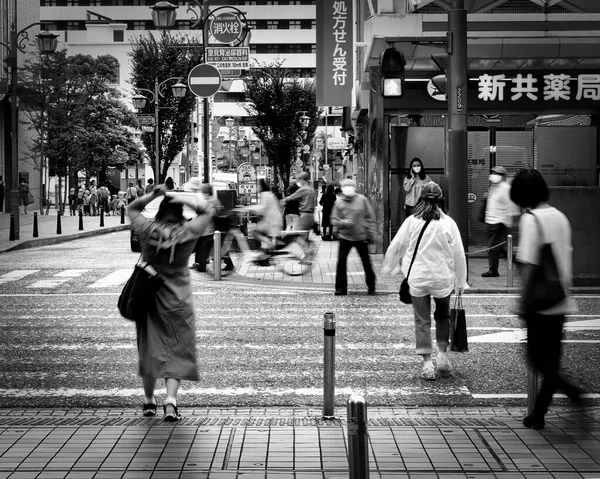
[150,0,250,183]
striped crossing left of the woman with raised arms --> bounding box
[0,268,133,291]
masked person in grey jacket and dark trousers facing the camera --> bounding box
[331,179,375,296]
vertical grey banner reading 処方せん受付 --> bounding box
[317,0,354,106]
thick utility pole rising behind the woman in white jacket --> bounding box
[446,0,469,250]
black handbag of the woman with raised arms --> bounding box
[117,261,164,322]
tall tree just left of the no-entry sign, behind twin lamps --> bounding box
[129,30,202,182]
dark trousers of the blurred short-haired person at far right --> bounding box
[526,314,579,416]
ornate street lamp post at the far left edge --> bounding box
[0,0,58,240]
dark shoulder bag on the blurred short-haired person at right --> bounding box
[521,211,566,314]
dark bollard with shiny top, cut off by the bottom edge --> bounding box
[346,394,369,479]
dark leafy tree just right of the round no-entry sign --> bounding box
[245,61,319,188]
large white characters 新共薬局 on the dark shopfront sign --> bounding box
[476,72,600,107]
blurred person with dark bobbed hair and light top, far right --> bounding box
[510,169,581,429]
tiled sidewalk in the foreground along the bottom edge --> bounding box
[0,408,600,479]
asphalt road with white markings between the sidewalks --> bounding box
[0,232,600,408]
